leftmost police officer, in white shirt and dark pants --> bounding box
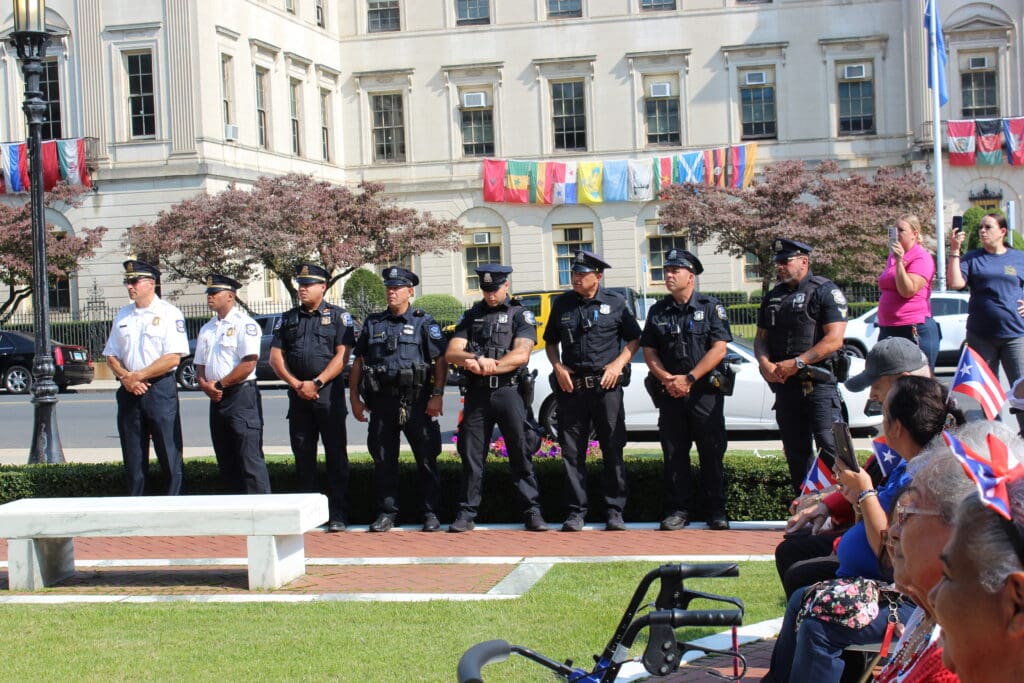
[103,260,188,496]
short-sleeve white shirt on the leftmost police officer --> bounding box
[103,297,188,372]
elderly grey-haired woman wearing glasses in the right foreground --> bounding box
[874,422,1024,683]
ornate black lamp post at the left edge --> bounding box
[11,0,65,464]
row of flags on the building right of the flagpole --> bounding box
[946,117,1024,166]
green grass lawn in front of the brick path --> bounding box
[0,562,783,683]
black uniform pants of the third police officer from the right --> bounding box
[557,387,627,516]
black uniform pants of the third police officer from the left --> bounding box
[288,381,348,521]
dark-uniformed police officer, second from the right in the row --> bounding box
[640,249,732,531]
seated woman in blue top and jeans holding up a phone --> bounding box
[762,377,963,683]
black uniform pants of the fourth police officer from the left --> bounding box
[367,394,441,515]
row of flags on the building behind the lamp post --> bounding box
[0,137,92,194]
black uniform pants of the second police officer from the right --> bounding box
[657,391,727,518]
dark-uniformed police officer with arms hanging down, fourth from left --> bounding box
[348,266,447,531]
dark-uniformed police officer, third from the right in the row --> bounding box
[544,251,640,531]
